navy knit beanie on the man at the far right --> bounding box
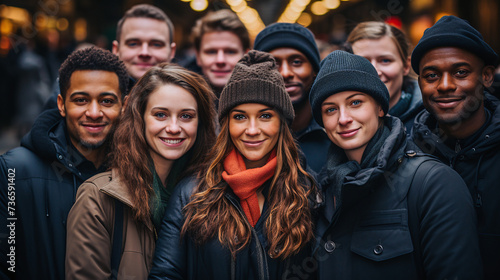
[411,16,498,74]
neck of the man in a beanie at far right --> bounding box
[439,105,486,139]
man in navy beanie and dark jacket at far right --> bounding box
[411,16,500,279]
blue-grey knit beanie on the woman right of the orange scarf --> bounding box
[309,51,389,126]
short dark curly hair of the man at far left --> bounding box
[59,47,129,99]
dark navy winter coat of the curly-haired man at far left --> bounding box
[0,109,106,280]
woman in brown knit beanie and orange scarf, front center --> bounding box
[150,51,318,279]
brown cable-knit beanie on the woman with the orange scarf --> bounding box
[219,50,295,124]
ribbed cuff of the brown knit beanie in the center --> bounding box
[219,79,295,124]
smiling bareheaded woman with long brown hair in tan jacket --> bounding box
[66,64,215,279]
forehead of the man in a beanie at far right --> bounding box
[420,47,484,70]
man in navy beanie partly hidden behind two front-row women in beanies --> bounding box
[254,23,330,172]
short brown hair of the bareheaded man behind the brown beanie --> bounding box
[191,9,250,51]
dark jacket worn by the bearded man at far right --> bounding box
[412,94,500,279]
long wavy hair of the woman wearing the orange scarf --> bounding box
[181,111,316,259]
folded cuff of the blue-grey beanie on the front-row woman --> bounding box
[310,69,389,127]
